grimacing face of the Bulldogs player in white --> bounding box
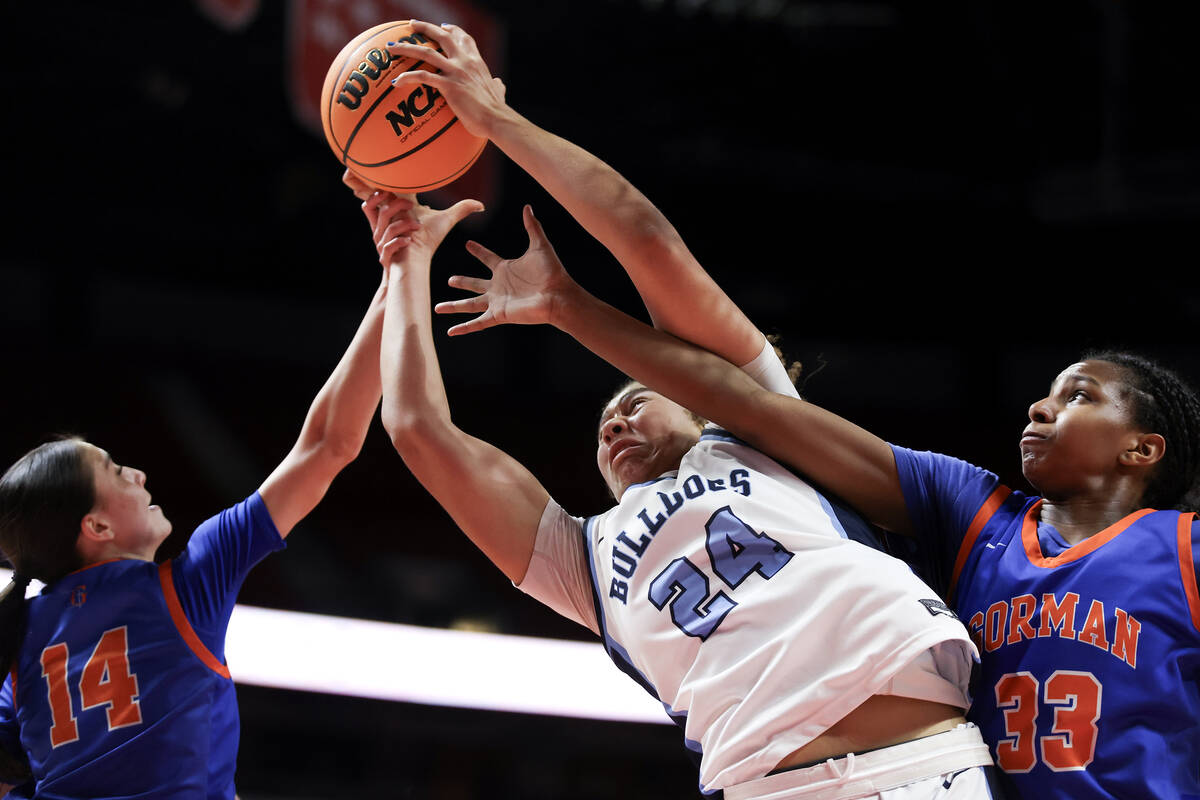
[596,384,700,500]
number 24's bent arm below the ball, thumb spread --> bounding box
[377,194,550,583]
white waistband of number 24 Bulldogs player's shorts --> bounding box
[724,722,992,800]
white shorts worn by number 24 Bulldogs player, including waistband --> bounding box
[725,722,1001,800]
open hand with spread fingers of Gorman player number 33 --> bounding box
[433,205,577,336]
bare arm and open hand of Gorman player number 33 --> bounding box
[437,207,911,533]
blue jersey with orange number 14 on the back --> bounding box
[0,493,283,799]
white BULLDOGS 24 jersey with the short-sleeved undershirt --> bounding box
[520,345,978,793]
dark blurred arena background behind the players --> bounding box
[0,0,1200,800]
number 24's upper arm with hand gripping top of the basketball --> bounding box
[392,20,763,365]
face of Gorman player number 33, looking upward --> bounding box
[1021,361,1142,500]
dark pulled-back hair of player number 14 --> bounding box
[0,438,96,784]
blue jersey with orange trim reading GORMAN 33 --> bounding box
[893,447,1200,800]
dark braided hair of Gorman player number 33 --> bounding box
[1084,351,1200,511]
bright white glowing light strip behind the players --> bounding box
[0,570,670,723]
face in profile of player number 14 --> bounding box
[83,445,170,561]
